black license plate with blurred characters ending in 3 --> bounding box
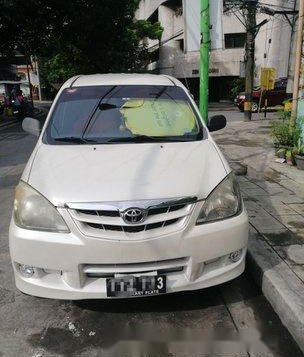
[107,275,166,297]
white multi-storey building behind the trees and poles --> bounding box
[137,0,296,101]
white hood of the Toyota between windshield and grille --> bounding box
[28,140,227,206]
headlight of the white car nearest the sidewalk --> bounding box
[196,172,242,224]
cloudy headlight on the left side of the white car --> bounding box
[14,181,69,232]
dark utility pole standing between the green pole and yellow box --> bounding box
[244,0,258,121]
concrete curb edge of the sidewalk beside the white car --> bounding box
[247,233,304,353]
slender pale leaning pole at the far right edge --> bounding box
[292,0,304,116]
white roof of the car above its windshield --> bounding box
[63,73,183,88]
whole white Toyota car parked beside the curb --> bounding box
[9,74,248,299]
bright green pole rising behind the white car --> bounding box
[200,0,210,123]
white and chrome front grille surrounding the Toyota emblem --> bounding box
[68,199,195,238]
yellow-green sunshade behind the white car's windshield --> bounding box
[120,99,197,136]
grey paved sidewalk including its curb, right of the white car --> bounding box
[213,118,304,352]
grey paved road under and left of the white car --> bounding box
[0,126,302,357]
